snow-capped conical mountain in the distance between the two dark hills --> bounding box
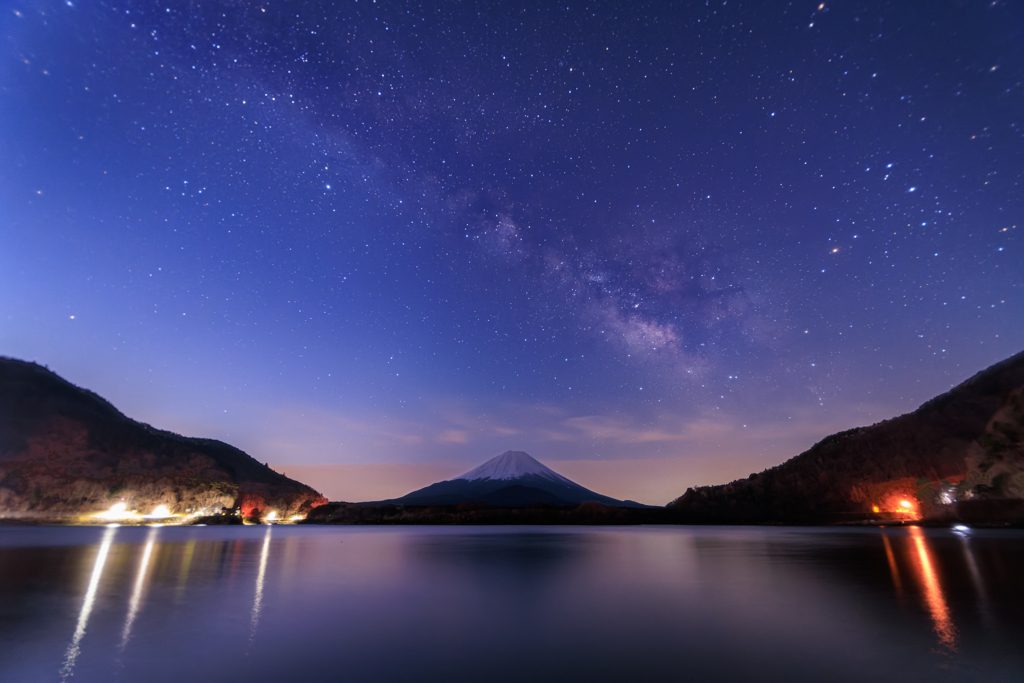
[381,451,646,508]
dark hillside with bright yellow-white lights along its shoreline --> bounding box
[0,357,327,518]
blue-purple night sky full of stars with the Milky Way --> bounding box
[0,0,1024,504]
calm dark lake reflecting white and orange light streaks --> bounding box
[0,526,1024,683]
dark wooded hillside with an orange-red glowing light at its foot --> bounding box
[668,352,1024,523]
